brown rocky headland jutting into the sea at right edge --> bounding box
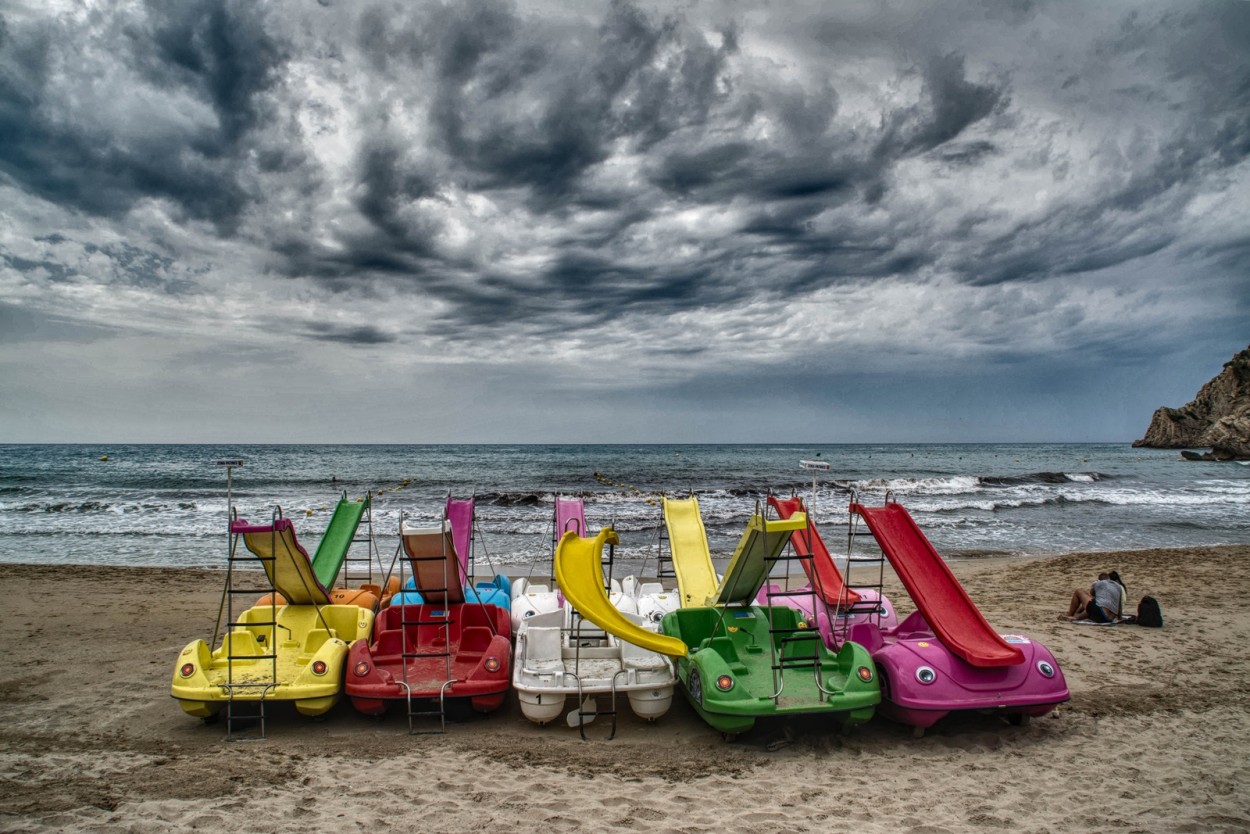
[1133,348,1250,460]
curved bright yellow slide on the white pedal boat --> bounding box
[555,528,686,658]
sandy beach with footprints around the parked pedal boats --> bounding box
[0,546,1250,833]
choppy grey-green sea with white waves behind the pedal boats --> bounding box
[0,444,1250,575]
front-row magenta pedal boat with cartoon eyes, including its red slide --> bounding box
[849,496,1069,736]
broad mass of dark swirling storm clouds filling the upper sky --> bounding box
[0,0,1250,355]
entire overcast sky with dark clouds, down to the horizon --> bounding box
[0,0,1250,443]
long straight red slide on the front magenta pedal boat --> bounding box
[851,504,1024,666]
